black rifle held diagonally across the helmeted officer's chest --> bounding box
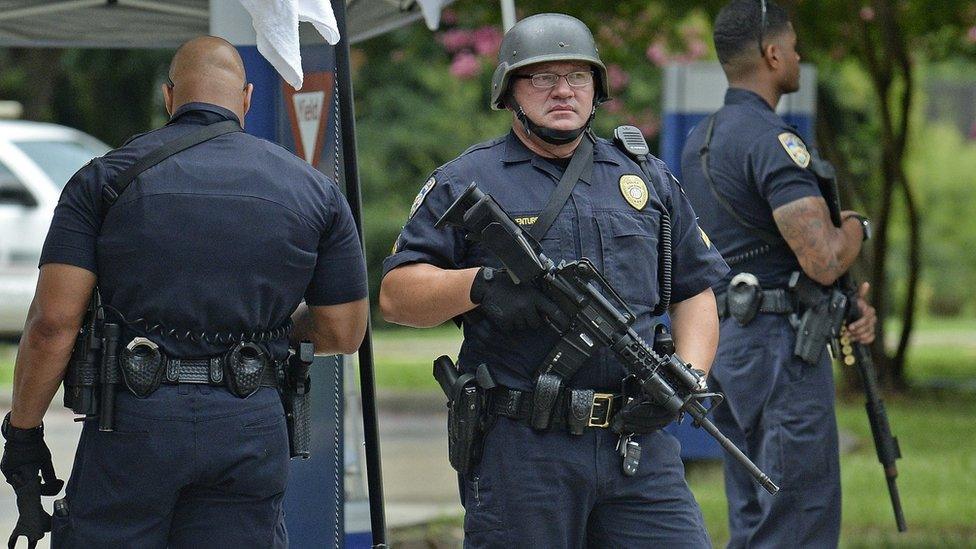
[435,183,779,494]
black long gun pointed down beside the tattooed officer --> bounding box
[812,156,907,532]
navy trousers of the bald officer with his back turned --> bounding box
[52,385,289,549]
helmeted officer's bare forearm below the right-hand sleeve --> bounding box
[669,288,718,373]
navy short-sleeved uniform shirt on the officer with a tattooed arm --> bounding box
[681,88,822,292]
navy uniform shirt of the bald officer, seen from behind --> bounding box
[40,103,366,358]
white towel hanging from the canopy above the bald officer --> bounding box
[239,0,339,90]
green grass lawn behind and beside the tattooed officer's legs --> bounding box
[688,390,976,548]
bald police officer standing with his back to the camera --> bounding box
[2,37,367,547]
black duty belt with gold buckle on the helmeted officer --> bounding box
[488,387,625,432]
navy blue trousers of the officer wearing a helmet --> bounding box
[461,417,711,549]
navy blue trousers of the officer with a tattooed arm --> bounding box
[710,314,840,548]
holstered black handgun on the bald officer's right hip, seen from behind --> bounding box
[282,341,315,459]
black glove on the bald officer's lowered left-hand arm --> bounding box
[0,413,64,549]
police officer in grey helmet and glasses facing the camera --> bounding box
[380,14,727,547]
